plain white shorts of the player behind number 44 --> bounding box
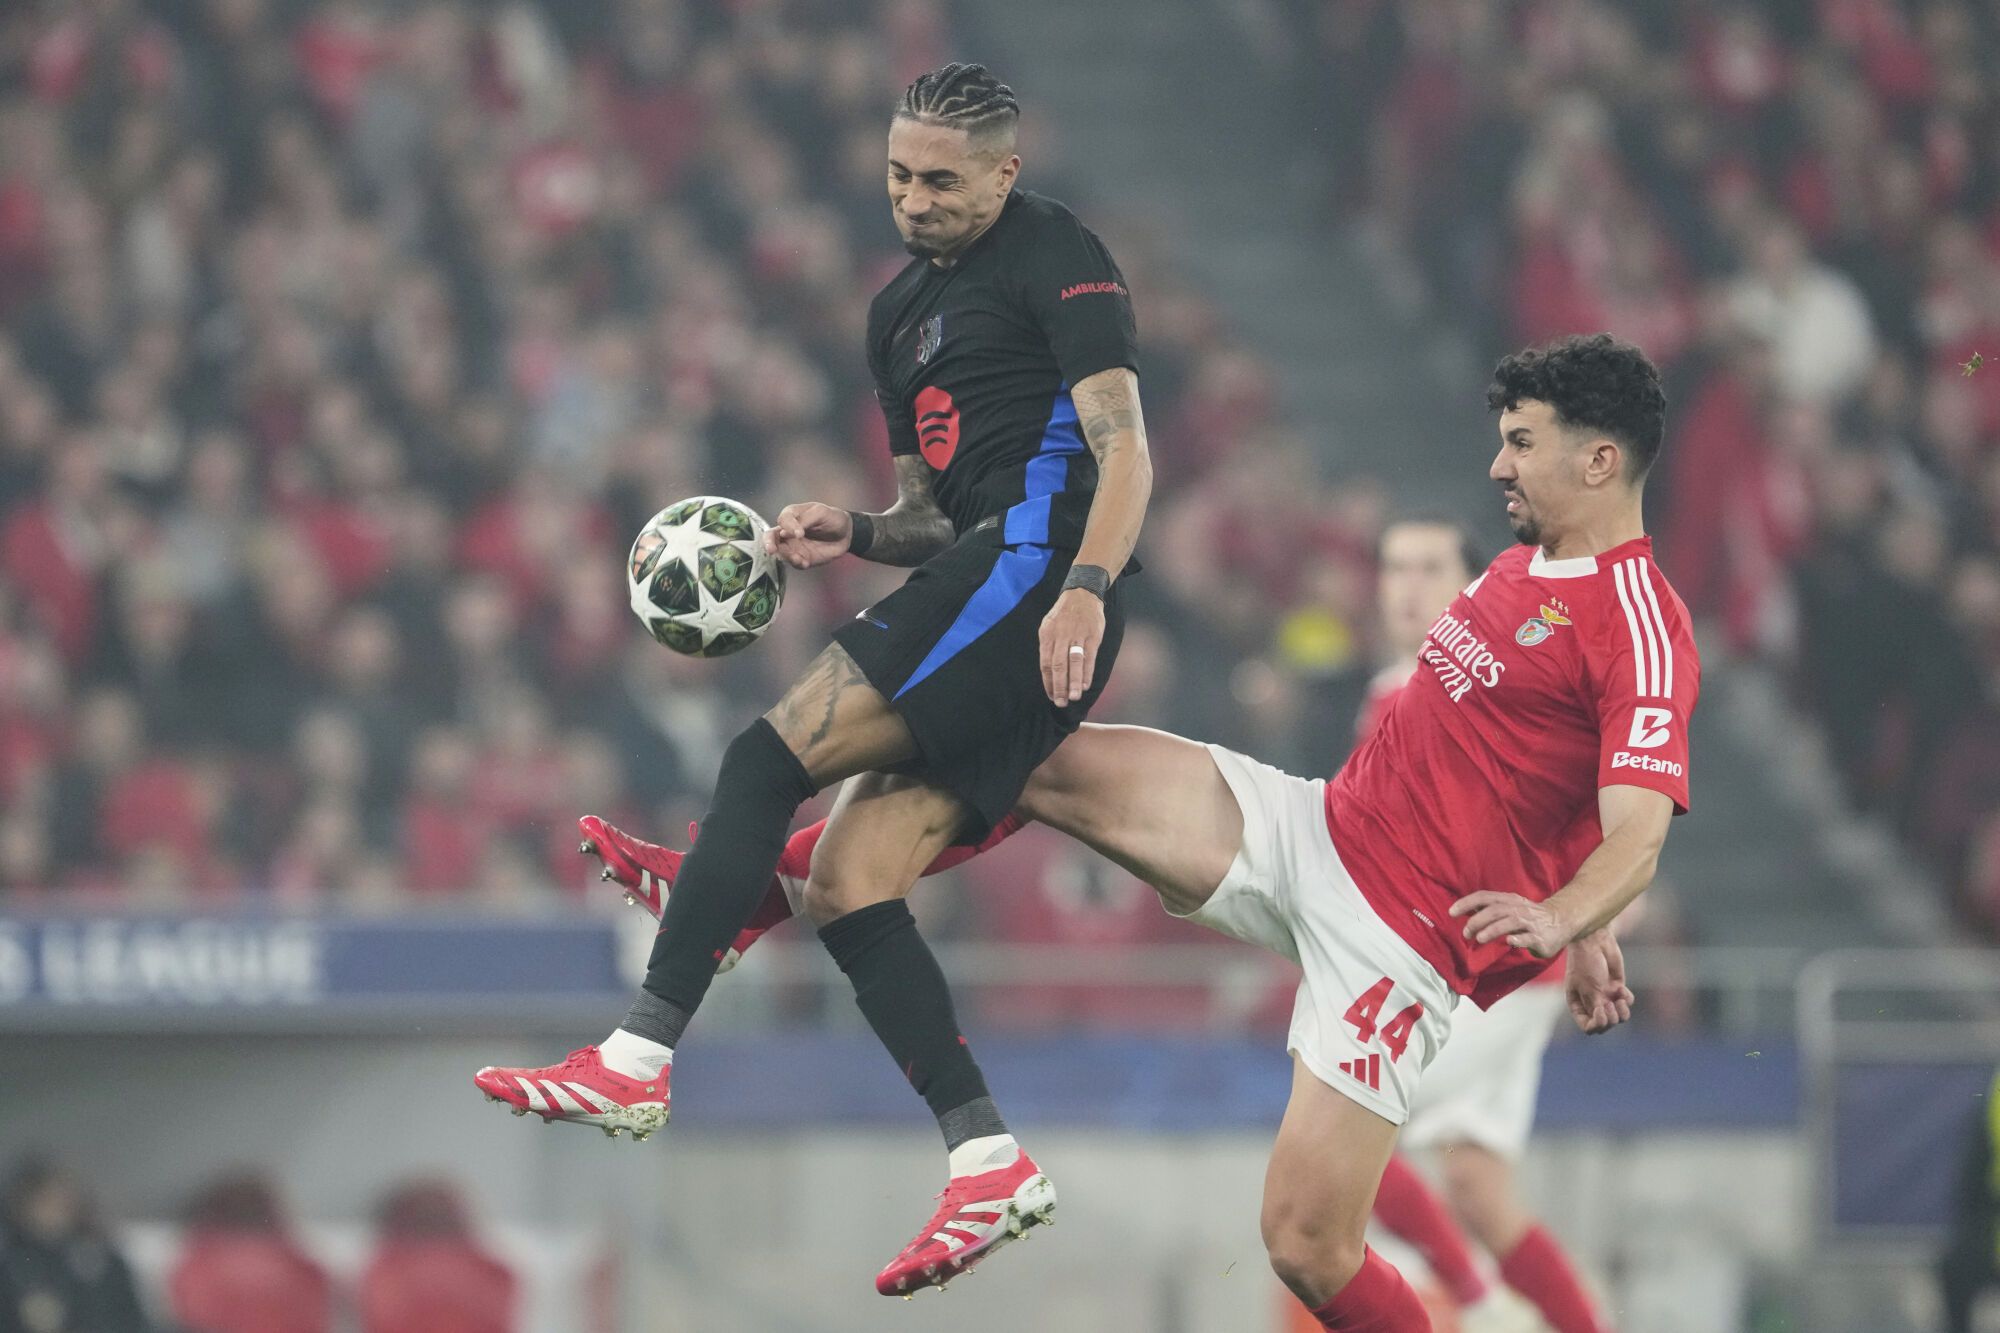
[1402,972,1564,1161]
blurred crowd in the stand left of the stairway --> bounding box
[0,0,1344,909]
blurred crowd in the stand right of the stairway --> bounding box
[1292,0,2000,923]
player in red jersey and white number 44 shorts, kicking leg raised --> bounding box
[586,334,1700,1333]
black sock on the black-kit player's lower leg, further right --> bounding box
[820,899,1006,1149]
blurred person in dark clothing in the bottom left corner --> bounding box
[0,1157,152,1333]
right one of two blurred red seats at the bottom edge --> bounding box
[360,1181,518,1333]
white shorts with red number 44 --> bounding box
[1188,745,1458,1125]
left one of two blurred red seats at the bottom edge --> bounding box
[166,1171,334,1333]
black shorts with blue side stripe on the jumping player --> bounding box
[834,526,1124,843]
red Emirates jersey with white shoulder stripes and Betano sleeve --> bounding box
[1326,536,1700,1007]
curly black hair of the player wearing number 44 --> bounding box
[1486,334,1666,480]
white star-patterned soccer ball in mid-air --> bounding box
[626,494,784,656]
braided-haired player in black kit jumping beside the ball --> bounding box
[476,64,1152,1295]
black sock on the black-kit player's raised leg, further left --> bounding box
[622,719,818,1047]
